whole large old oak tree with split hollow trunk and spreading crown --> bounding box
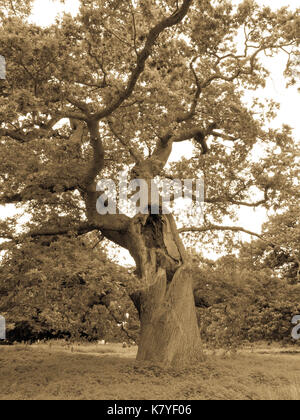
[0,0,299,364]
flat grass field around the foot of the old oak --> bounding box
[0,343,300,400]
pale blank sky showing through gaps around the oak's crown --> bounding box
[0,0,300,262]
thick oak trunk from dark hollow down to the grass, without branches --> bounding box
[131,215,201,366]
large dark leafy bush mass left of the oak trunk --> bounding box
[0,237,138,341]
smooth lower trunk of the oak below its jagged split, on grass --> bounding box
[137,267,202,366]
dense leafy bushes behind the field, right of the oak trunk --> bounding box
[193,256,300,348]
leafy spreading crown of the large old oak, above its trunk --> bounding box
[0,1,299,249]
